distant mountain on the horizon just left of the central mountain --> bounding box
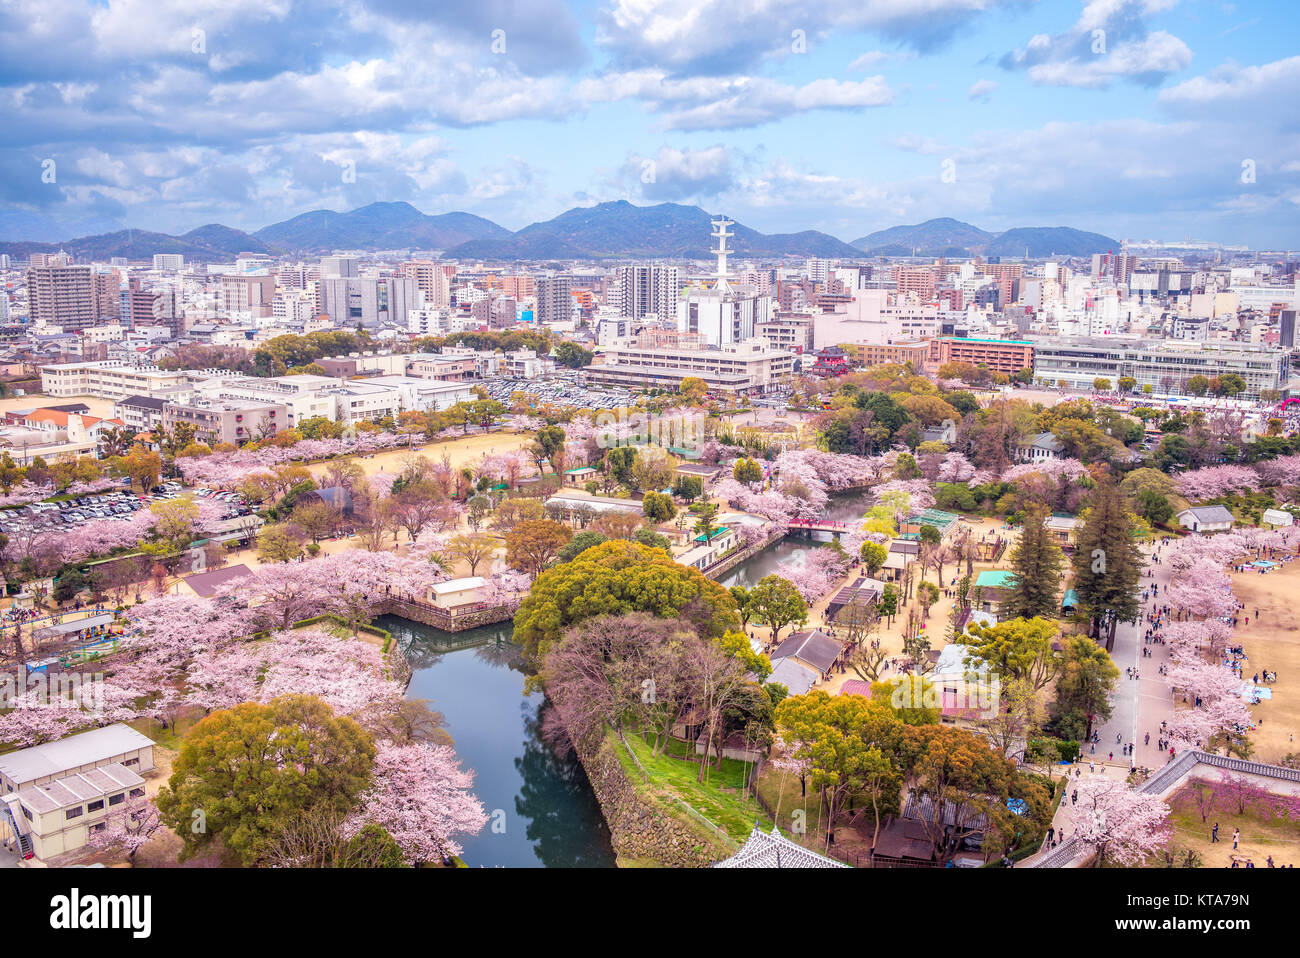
[254,203,511,252]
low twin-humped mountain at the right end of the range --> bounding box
[853,217,1119,259]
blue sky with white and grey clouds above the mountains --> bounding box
[0,0,1300,248]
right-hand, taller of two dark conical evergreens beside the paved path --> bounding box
[1073,482,1143,649]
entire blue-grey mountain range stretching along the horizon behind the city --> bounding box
[0,200,1119,263]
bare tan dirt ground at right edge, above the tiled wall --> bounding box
[1229,563,1300,762]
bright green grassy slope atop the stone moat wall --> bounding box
[624,736,771,842]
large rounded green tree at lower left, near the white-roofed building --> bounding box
[156,695,374,866]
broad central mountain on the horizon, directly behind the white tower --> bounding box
[447,200,858,260]
